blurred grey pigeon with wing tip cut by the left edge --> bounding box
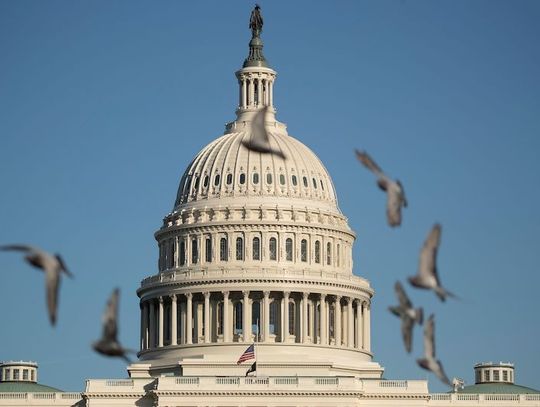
[0,244,73,326]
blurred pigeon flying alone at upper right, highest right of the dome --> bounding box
[355,150,407,227]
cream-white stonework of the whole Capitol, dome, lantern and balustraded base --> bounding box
[0,7,540,407]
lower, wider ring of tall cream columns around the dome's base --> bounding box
[141,291,371,351]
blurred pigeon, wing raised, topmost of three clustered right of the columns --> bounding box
[409,223,456,301]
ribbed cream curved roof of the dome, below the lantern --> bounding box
[174,121,339,212]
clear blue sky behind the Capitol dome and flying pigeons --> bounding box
[0,0,540,391]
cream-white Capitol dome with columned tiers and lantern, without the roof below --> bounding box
[133,7,383,378]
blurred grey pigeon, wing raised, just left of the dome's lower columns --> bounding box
[92,288,135,364]
